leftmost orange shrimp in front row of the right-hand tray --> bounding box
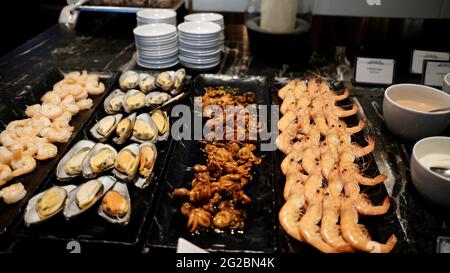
[278,193,305,242]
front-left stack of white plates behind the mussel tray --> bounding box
[133,24,178,69]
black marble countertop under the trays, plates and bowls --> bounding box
[0,14,450,253]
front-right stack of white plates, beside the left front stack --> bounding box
[178,22,221,69]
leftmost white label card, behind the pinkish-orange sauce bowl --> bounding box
[355,57,395,85]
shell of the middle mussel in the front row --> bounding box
[63,176,116,220]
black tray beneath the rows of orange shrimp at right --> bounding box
[272,78,409,253]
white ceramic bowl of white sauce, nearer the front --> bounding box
[411,137,450,208]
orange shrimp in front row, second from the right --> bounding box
[320,195,353,252]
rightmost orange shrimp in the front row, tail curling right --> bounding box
[340,198,397,253]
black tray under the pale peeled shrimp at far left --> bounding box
[0,68,117,234]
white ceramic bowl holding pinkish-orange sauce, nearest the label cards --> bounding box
[383,84,450,140]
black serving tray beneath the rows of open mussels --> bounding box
[13,71,190,246]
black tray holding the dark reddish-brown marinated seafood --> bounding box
[147,74,277,252]
